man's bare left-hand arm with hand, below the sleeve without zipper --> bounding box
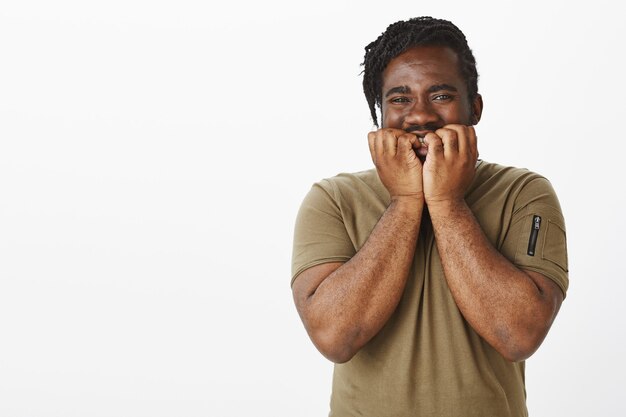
[293,129,424,363]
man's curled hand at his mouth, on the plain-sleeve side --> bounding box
[367,128,424,199]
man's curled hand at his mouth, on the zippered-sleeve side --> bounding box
[423,124,478,211]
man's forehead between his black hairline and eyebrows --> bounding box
[383,45,465,93]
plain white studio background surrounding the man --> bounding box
[0,0,626,417]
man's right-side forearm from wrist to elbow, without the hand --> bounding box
[429,201,556,360]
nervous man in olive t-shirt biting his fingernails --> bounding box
[292,17,568,417]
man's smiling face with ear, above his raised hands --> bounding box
[382,46,482,137]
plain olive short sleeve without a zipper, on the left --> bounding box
[291,180,356,285]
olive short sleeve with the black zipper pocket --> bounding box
[502,178,569,295]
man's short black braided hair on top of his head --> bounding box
[361,16,478,126]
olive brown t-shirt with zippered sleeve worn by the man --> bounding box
[292,161,568,417]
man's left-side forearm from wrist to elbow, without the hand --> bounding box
[301,197,424,362]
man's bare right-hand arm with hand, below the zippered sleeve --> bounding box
[424,125,563,361]
